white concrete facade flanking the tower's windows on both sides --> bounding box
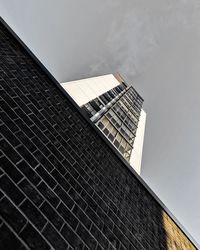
[61,74,146,174]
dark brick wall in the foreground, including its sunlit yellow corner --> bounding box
[0,20,195,250]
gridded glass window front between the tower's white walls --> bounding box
[82,83,143,161]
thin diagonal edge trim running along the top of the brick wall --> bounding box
[0,16,200,249]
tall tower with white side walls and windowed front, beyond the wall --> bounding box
[61,74,146,174]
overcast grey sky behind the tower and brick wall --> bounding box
[0,0,200,244]
